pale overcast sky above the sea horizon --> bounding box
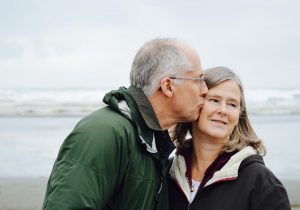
[0,0,300,88]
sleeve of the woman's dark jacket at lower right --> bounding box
[251,168,291,210]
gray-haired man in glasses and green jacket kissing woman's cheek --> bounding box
[43,39,207,210]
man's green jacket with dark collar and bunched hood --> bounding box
[43,87,174,210]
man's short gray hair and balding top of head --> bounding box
[130,38,192,96]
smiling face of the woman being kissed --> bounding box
[197,80,241,143]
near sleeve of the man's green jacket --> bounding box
[43,120,129,210]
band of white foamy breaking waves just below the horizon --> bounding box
[0,89,300,116]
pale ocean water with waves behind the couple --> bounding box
[0,89,300,180]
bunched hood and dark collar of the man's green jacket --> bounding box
[103,86,161,153]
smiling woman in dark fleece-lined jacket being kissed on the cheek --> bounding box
[169,67,290,210]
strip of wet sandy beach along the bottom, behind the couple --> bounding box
[0,177,300,210]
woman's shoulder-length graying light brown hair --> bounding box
[173,67,266,155]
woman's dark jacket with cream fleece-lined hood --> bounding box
[169,147,291,210]
